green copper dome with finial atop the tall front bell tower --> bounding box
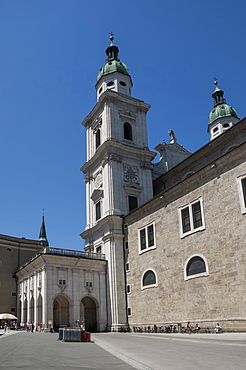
[97,37,129,82]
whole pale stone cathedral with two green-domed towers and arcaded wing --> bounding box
[0,35,246,331]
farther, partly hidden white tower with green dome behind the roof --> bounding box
[208,78,239,140]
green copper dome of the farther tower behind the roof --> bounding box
[208,86,238,125]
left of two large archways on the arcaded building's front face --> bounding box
[53,294,69,327]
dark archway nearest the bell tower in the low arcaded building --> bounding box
[80,297,97,331]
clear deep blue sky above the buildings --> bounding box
[0,0,246,249]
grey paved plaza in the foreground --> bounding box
[0,332,246,370]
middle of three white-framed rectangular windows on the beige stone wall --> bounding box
[179,198,205,237]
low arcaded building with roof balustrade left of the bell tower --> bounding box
[16,247,108,331]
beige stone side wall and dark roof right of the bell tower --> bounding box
[124,119,246,331]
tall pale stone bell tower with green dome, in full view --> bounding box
[81,34,156,330]
